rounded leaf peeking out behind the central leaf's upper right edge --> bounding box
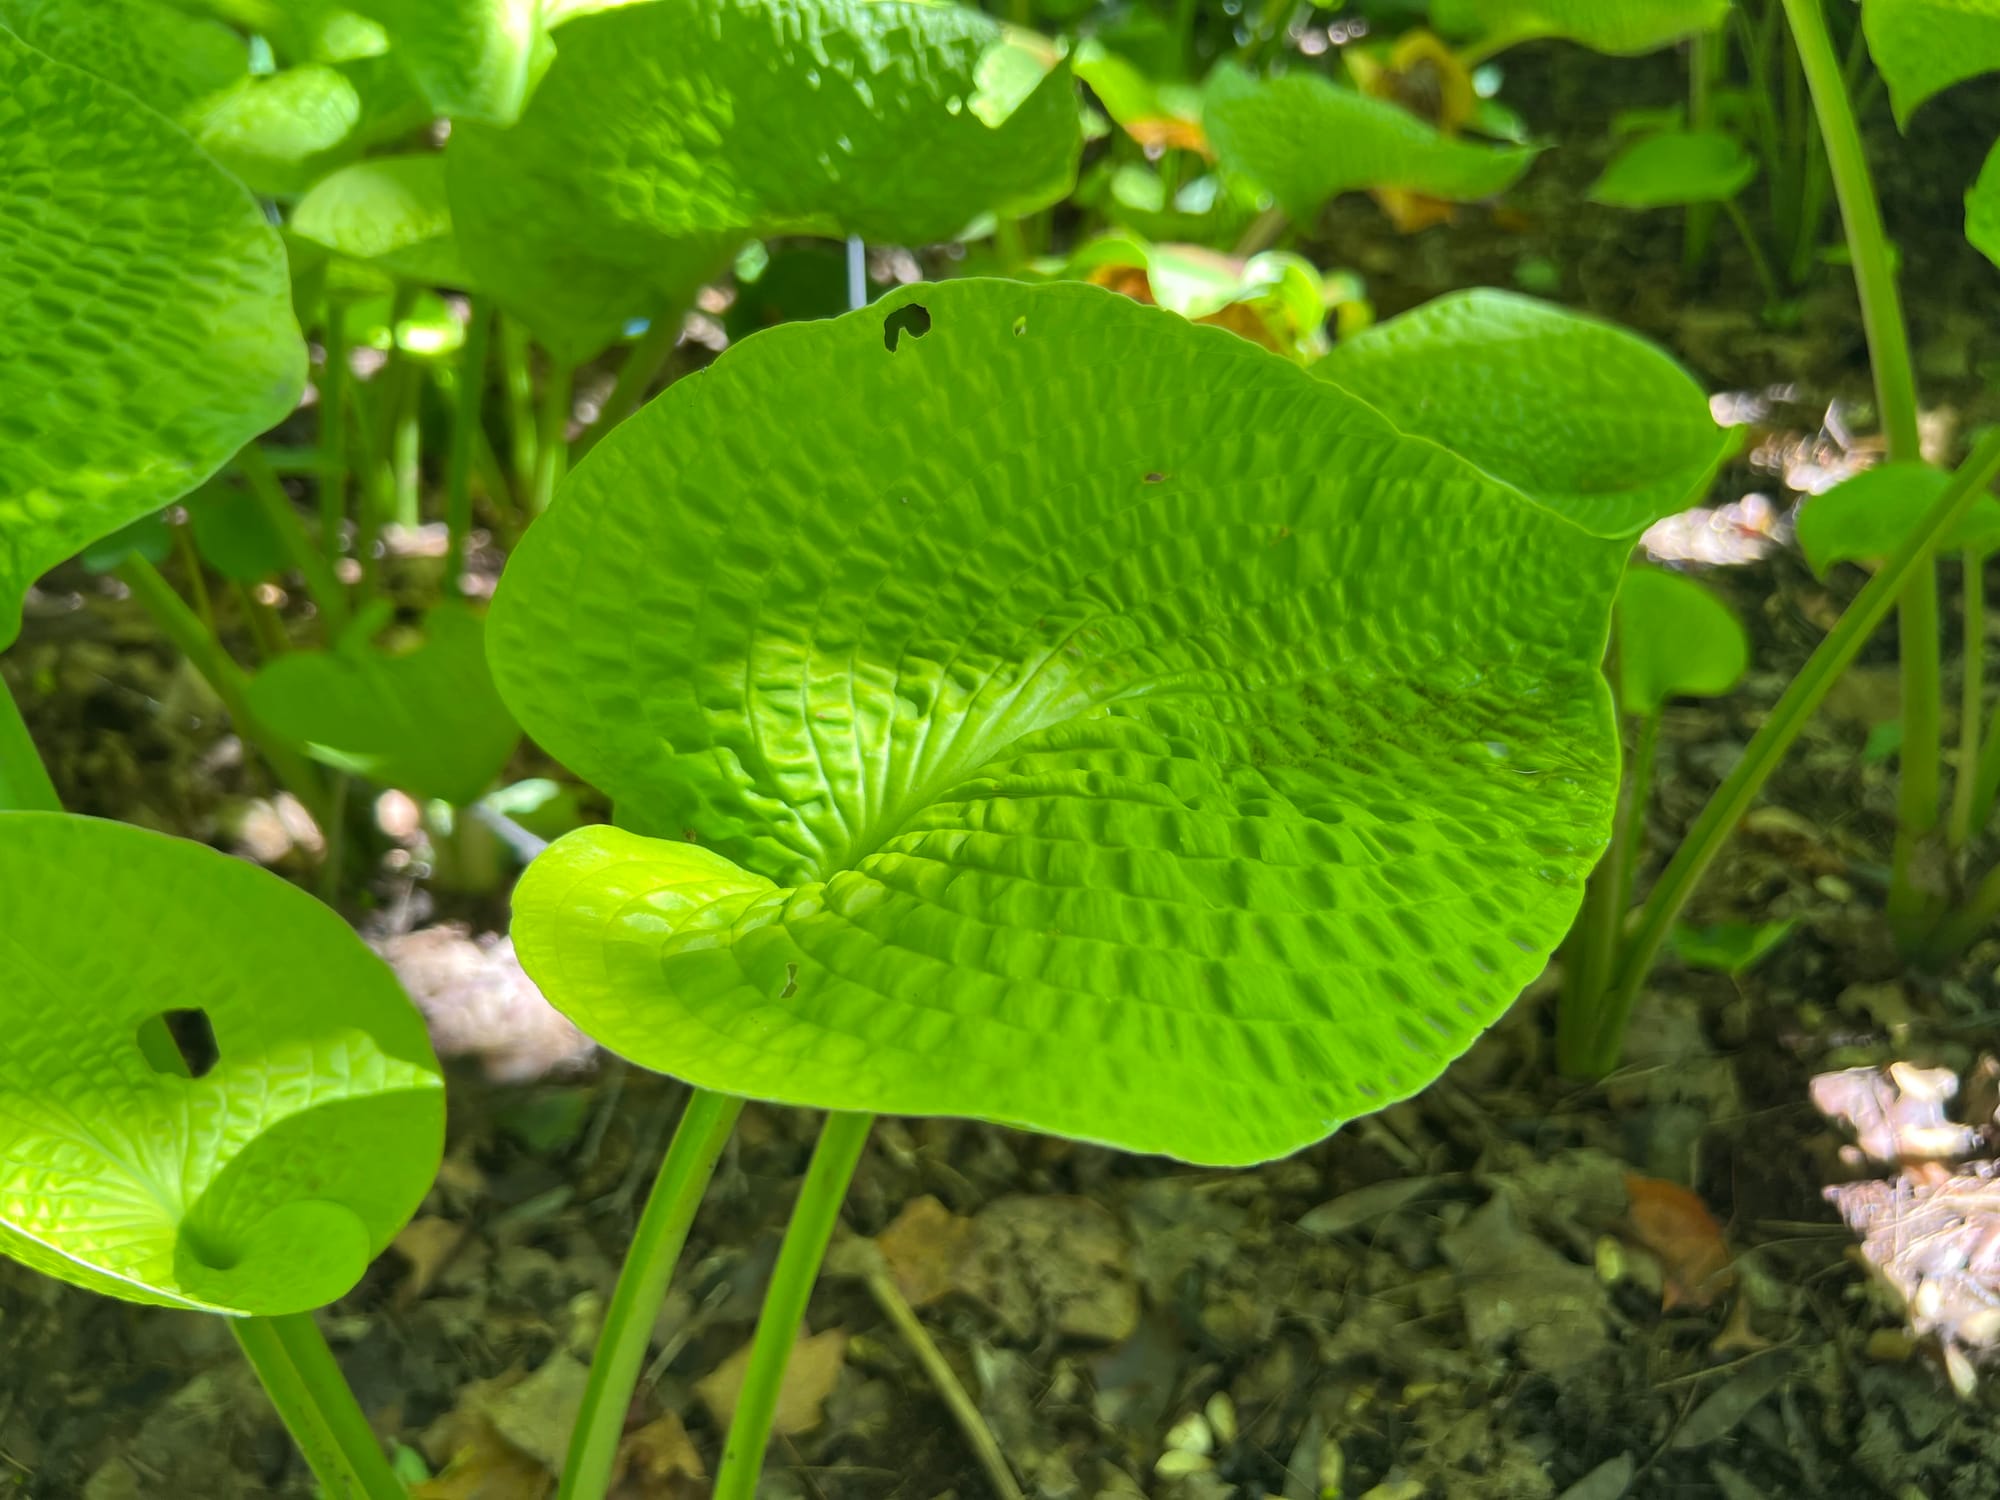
[1314,288,1732,536]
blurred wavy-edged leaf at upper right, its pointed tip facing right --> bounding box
[1202,62,1538,220]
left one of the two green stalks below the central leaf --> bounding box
[558,1088,744,1500]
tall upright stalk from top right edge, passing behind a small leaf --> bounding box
[1782,0,1944,934]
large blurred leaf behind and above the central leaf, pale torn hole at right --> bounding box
[448,0,1082,354]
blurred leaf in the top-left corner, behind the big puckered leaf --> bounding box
[0,0,250,114]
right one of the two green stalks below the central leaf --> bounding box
[714,1114,874,1500]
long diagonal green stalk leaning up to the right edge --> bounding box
[1590,428,2000,1074]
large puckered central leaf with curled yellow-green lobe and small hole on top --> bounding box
[490,280,1626,1162]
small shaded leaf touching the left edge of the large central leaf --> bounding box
[250,604,520,804]
